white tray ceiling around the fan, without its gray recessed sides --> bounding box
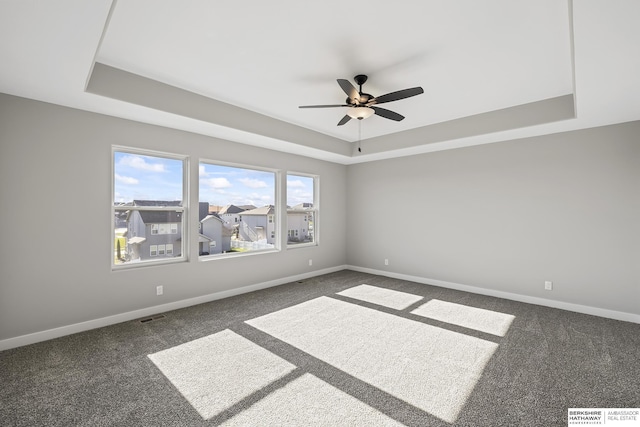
[0,0,640,164]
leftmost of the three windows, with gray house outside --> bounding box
[112,147,188,268]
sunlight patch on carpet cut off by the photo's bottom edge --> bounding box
[222,374,403,427]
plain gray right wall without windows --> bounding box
[347,122,640,314]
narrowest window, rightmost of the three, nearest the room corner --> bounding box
[287,174,318,247]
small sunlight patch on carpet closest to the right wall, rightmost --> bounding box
[411,299,515,337]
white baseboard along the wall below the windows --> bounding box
[0,265,347,351]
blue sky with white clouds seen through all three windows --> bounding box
[114,151,313,207]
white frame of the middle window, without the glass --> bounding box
[197,158,286,262]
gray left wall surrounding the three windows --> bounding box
[0,94,346,340]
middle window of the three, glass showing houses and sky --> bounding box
[199,161,278,257]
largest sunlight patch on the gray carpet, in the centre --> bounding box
[245,297,498,423]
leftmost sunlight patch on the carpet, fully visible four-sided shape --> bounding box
[148,329,296,420]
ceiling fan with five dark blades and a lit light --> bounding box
[299,74,424,126]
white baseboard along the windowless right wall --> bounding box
[346,265,640,324]
